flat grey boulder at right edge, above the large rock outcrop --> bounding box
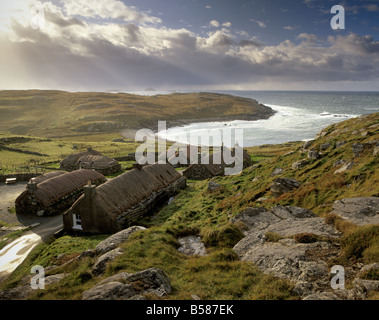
[331,197,379,226]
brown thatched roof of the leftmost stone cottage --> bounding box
[16,169,105,207]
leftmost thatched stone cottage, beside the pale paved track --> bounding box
[15,169,105,216]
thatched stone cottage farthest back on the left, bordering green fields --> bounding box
[60,148,121,175]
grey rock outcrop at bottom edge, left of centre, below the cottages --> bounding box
[82,268,172,300]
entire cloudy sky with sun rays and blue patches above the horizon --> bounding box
[0,0,379,91]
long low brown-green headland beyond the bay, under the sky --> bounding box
[0,90,274,137]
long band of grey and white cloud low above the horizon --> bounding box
[0,1,379,90]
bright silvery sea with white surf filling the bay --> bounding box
[125,90,379,147]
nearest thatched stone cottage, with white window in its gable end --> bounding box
[63,164,186,233]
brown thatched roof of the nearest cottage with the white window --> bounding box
[72,164,182,218]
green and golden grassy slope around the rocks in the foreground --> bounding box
[1,113,379,299]
